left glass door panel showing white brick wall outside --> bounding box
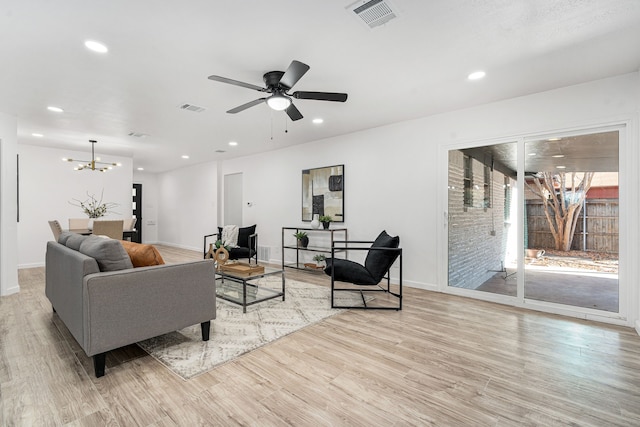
[448,142,518,296]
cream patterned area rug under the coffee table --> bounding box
[138,278,361,380]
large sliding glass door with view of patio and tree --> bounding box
[447,128,624,317]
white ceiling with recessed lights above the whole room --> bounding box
[0,0,640,172]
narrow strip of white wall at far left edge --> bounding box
[0,113,20,296]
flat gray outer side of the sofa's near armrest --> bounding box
[81,260,216,356]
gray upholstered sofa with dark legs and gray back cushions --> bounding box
[45,233,216,377]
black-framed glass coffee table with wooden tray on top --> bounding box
[216,267,285,313]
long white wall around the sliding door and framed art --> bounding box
[155,73,640,324]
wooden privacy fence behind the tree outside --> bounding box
[526,199,620,254]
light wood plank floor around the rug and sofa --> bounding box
[0,247,640,427]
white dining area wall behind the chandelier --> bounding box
[17,144,133,268]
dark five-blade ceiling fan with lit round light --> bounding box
[209,60,347,121]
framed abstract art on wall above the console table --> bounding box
[302,165,344,222]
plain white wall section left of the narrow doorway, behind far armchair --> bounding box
[155,163,218,250]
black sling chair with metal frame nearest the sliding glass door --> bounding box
[324,231,402,310]
